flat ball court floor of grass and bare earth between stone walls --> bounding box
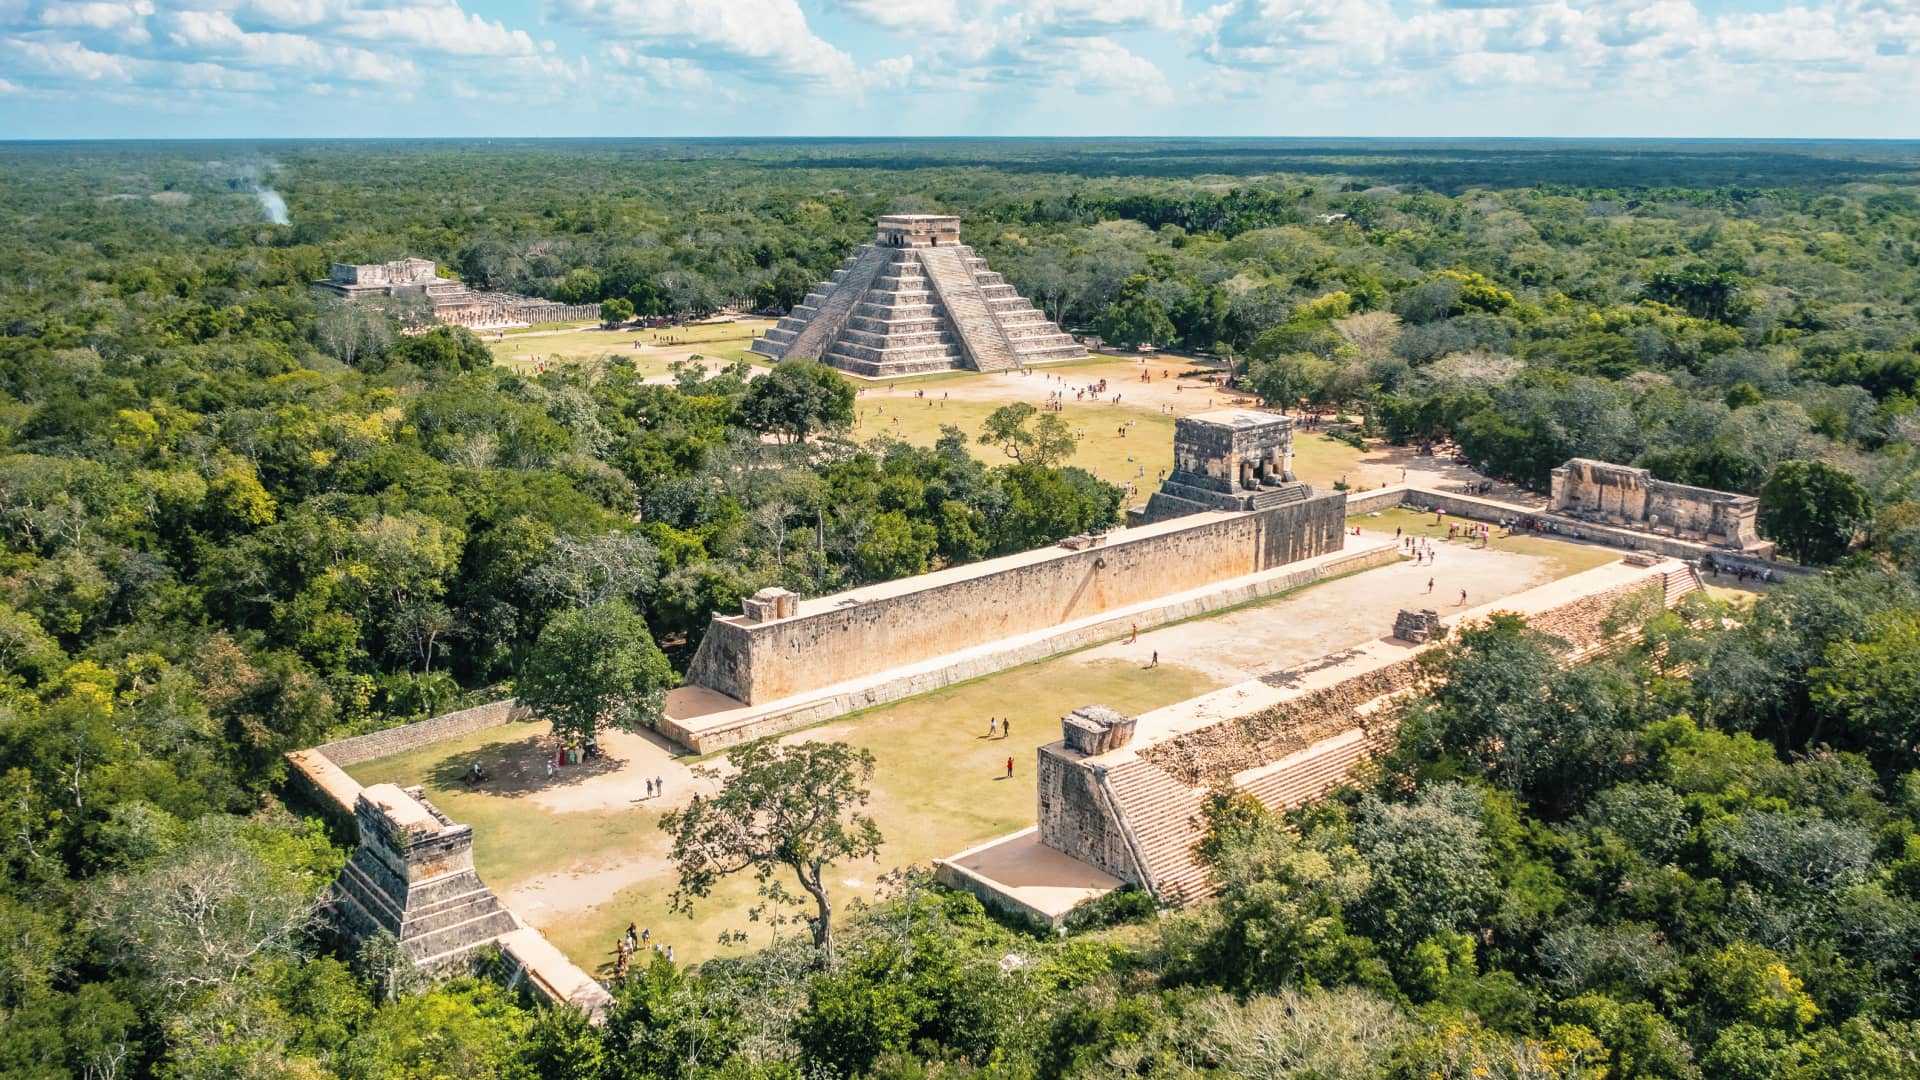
[349,511,1617,970]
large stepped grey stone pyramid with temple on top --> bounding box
[753,213,1087,379]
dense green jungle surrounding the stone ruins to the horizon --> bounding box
[0,138,1920,1080]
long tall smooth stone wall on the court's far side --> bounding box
[687,492,1346,703]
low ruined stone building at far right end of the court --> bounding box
[1549,457,1774,559]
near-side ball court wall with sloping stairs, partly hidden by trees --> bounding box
[956,559,1699,907]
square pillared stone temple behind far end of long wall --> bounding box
[1131,409,1313,525]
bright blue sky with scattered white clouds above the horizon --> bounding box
[0,0,1920,138]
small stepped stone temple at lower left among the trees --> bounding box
[334,784,518,970]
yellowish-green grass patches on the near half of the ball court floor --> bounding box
[349,655,1217,969]
